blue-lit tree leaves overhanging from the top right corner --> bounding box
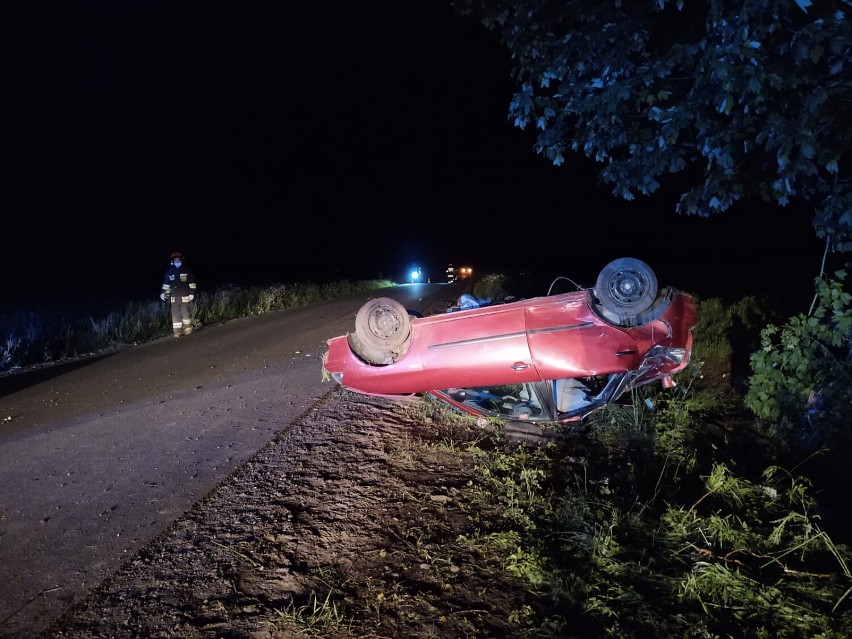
[454,0,852,251]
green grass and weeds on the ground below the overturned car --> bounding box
[364,384,852,639]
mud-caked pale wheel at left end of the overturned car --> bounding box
[350,297,411,364]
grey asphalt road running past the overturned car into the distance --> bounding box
[0,284,452,639]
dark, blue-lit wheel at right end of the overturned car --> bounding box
[595,257,658,318]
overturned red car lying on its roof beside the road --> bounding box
[323,257,696,422]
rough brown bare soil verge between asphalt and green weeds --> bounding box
[43,390,529,639]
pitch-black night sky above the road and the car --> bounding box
[0,0,836,311]
